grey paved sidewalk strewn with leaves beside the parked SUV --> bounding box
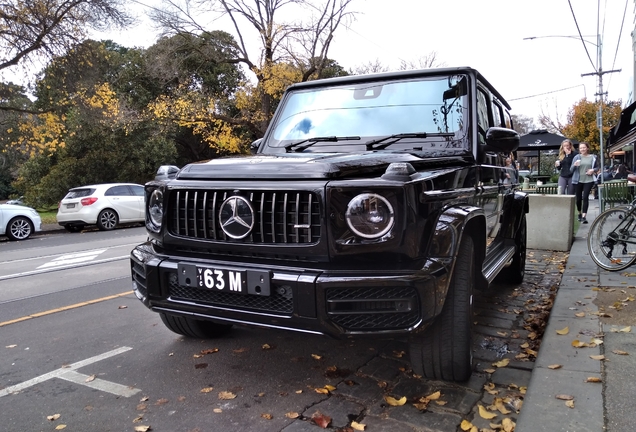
[515,200,636,432]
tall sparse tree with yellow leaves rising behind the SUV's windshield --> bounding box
[152,0,354,138]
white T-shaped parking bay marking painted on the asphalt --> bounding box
[0,347,141,397]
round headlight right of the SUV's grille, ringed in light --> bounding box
[345,193,395,239]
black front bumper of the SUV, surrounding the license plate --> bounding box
[131,242,449,337]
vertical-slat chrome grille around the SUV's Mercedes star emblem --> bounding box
[169,189,321,244]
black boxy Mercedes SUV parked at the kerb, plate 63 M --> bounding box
[131,67,528,380]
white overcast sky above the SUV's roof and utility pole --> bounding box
[99,0,634,122]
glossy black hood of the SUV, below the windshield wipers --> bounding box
[177,151,468,180]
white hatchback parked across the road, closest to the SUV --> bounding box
[57,183,145,232]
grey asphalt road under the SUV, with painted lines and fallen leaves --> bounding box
[0,228,558,432]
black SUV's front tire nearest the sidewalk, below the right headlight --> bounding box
[410,236,475,381]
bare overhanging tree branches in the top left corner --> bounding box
[0,0,131,95]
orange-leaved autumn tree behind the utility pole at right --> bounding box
[559,98,622,153]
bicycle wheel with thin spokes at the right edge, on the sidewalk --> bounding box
[587,207,636,271]
